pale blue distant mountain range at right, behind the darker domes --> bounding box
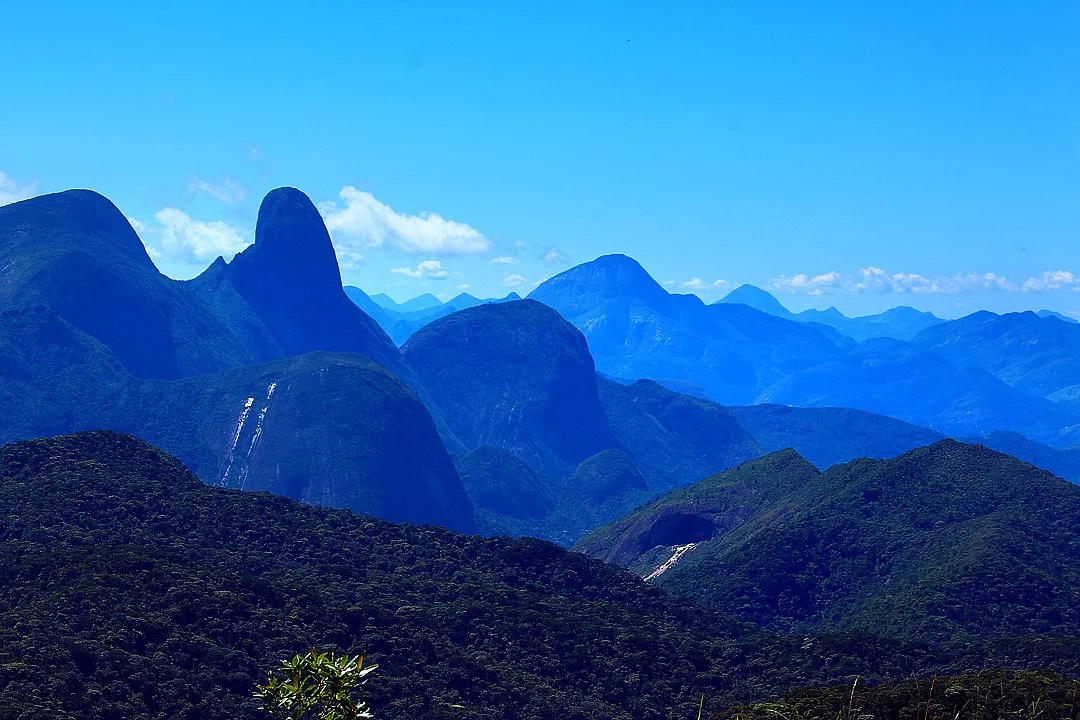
[529,255,1080,447]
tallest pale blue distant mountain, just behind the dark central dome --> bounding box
[529,255,842,404]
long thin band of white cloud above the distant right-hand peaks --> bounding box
[769,266,1080,296]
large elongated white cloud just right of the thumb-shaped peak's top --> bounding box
[319,186,491,255]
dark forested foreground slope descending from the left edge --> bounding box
[0,432,921,720]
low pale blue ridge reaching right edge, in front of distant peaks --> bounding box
[756,338,1078,447]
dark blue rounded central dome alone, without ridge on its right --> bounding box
[402,300,616,475]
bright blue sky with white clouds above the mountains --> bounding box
[0,0,1080,316]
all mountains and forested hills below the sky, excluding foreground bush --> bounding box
[6,188,1080,720]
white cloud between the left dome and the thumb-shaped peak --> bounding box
[127,207,249,264]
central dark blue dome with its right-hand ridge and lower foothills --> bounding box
[402,300,761,543]
